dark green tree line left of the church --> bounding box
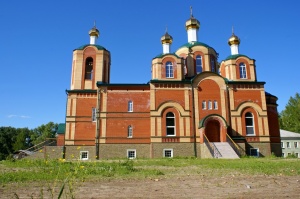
[0,122,58,161]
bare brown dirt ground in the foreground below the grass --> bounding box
[0,174,300,199]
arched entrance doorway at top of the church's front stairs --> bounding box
[199,115,228,143]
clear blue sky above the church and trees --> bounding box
[0,0,300,129]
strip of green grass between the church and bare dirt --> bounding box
[0,158,300,184]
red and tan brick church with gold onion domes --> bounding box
[58,10,281,160]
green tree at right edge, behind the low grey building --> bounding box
[279,93,300,133]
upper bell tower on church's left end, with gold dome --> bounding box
[71,25,110,90]
